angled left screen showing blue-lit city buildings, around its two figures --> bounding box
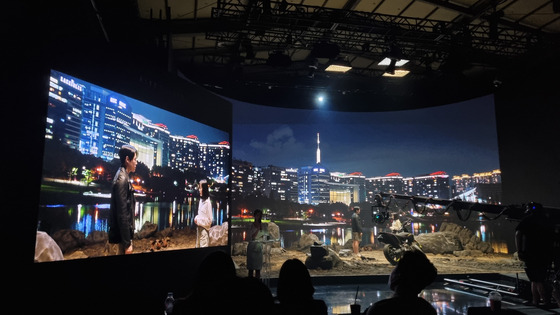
[35,69,231,262]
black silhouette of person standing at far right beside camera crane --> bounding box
[515,203,554,305]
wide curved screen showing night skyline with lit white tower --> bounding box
[231,95,517,272]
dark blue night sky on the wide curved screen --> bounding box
[230,95,500,177]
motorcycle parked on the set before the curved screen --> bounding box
[377,219,422,266]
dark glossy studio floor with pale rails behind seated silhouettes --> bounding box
[265,274,560,315]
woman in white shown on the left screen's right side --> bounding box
[194,180,213,248]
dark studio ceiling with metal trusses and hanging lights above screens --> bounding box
[39,0,560,111]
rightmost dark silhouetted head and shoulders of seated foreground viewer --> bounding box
[365,250,437,315]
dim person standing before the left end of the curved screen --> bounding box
[247,209,266,279]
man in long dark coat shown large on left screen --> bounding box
[107,145,138,255]
